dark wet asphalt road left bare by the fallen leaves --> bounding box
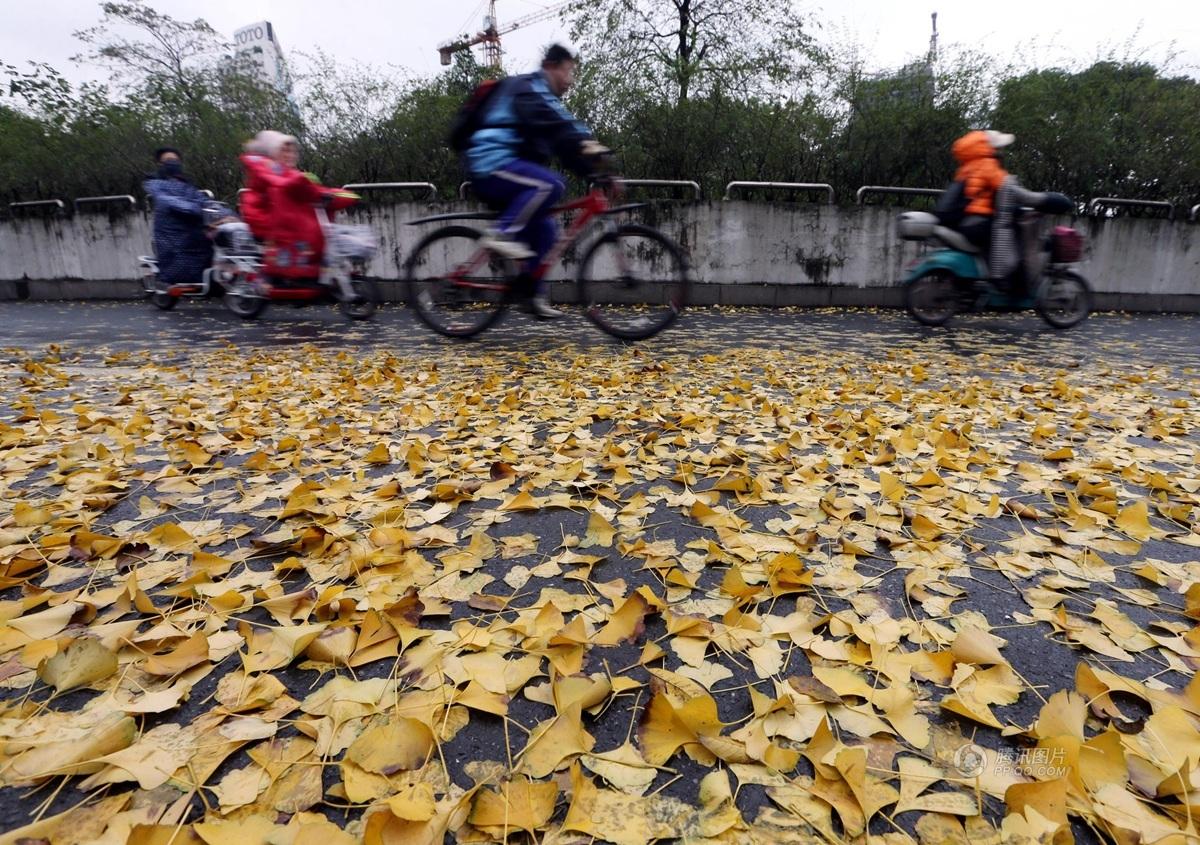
[0,302,1200,840]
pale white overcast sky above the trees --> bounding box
[0,0,1200,86]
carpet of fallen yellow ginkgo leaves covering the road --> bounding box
[0,328,1200,845]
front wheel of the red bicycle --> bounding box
[576,223,691,341]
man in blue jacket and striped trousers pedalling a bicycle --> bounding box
[464,44,608,319]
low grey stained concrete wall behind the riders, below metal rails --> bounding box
[0,202,1200,311]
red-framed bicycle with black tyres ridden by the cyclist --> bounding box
[404,187,691,341]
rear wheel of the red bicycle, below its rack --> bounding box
[404,226,516,337]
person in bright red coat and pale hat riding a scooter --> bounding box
[241,131,358,282]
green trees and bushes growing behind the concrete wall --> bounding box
[0,0,1200,205]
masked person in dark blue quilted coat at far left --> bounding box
[143,146,212,284]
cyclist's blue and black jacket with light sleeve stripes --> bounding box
[464,71,594,179]
